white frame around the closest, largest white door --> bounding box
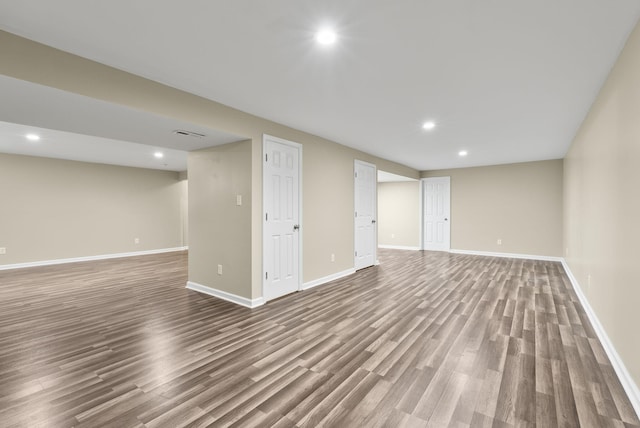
[260,134,304,302]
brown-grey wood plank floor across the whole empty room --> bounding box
[0,250,640,427]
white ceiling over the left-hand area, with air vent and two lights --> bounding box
[0,75,243,171]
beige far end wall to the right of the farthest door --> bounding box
[422,160,562,257]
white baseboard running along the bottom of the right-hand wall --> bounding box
[562,258,640,418]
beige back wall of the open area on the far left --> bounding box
[0,154,183,265]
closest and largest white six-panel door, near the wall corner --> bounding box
[263,135,302,300]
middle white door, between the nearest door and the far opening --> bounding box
[354,160,378,270]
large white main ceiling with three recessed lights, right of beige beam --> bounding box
[0,0,640,170]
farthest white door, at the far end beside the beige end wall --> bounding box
[422,177,451,251]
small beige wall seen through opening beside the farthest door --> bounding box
[378,181,420,248]
